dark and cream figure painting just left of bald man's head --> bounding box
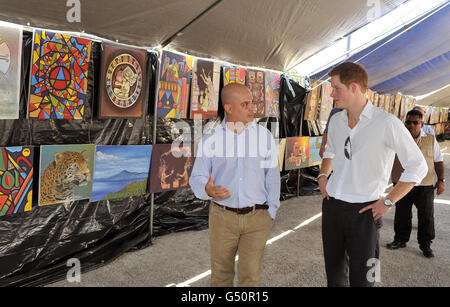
[190,59,220,119]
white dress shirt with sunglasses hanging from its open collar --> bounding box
[323,101,428,203]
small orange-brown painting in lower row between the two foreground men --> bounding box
[284,136,309,170]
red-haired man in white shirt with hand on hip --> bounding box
[318,62,428,286]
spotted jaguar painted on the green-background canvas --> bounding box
[39,150,91,206]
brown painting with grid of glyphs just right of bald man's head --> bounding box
[245,69,266,118]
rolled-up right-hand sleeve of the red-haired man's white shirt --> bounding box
[386,116,428,184]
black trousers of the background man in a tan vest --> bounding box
[394,186,435,248]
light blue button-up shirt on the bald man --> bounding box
[189,118,280,219]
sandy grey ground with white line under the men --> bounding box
[48,141,450,287]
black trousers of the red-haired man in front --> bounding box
[322,197,382,287]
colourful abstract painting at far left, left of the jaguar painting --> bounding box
[0,147,34,216]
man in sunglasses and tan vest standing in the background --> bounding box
[387,109,445,258]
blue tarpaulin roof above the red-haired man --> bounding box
[311,1,450,96]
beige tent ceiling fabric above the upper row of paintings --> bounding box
[0,0,405,71]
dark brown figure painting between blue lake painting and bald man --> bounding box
[150,144,194,193]
